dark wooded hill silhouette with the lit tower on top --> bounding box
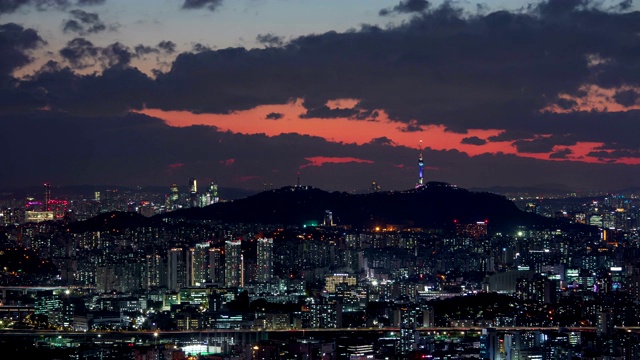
[157,182,588,232]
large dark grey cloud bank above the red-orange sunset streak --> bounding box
[8,0,640,160]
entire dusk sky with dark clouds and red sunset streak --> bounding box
[0,0,640,192]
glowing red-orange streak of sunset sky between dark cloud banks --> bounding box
[140,96,640,166]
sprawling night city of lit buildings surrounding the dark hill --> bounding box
[0,179,640,360]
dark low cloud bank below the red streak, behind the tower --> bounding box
[0,112,640,191]
